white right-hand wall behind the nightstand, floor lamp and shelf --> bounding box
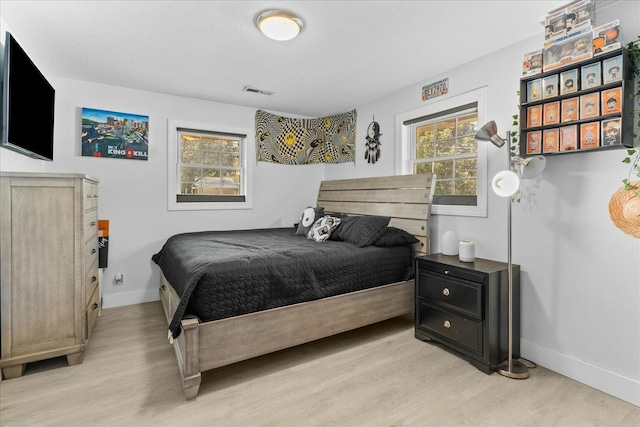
[326,2,640,406]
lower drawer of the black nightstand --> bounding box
[417,301,482,355]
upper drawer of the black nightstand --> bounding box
[418,271,483,320]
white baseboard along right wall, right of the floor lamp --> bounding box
[520,339,640,406]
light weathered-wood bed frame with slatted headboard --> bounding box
[160,174,434,400]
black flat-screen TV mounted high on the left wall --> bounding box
[1,32,56,161]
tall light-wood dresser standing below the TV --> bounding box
[0,172,100,379]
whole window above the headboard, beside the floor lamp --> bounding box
[396,85,487,216]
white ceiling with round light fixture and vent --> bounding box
[0,0,567,117]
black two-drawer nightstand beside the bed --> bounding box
[415,254,520,374]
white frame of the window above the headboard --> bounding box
[396,86,489,217]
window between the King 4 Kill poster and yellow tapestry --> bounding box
[169,121,251,210]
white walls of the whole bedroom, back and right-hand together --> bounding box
[0,2,640,406]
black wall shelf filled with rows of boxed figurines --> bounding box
[519,48,633,157]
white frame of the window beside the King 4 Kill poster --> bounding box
[167,120,255,211]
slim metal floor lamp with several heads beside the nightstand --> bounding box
[476,120,546,379]
